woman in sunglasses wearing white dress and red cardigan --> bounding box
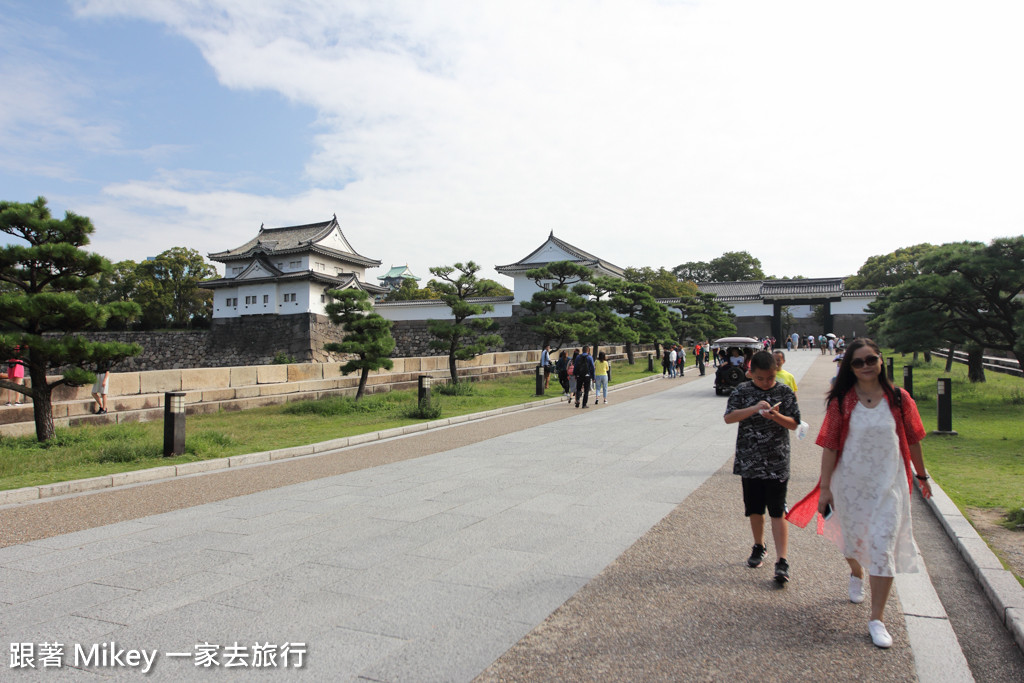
[787,338,932,648]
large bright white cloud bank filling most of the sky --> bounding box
[68,0,1024,276]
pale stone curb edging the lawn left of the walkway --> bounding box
[0,375,663,509]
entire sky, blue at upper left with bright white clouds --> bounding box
[0,0,1024,280]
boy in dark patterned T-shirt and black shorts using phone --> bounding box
[725,351,800,584]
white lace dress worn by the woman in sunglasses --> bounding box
[824,399,918,577]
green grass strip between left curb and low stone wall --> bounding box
[0,359,660,490]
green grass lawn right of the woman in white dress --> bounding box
[893,354,1024,524]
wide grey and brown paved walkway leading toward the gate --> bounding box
[0,352,1019,681]
